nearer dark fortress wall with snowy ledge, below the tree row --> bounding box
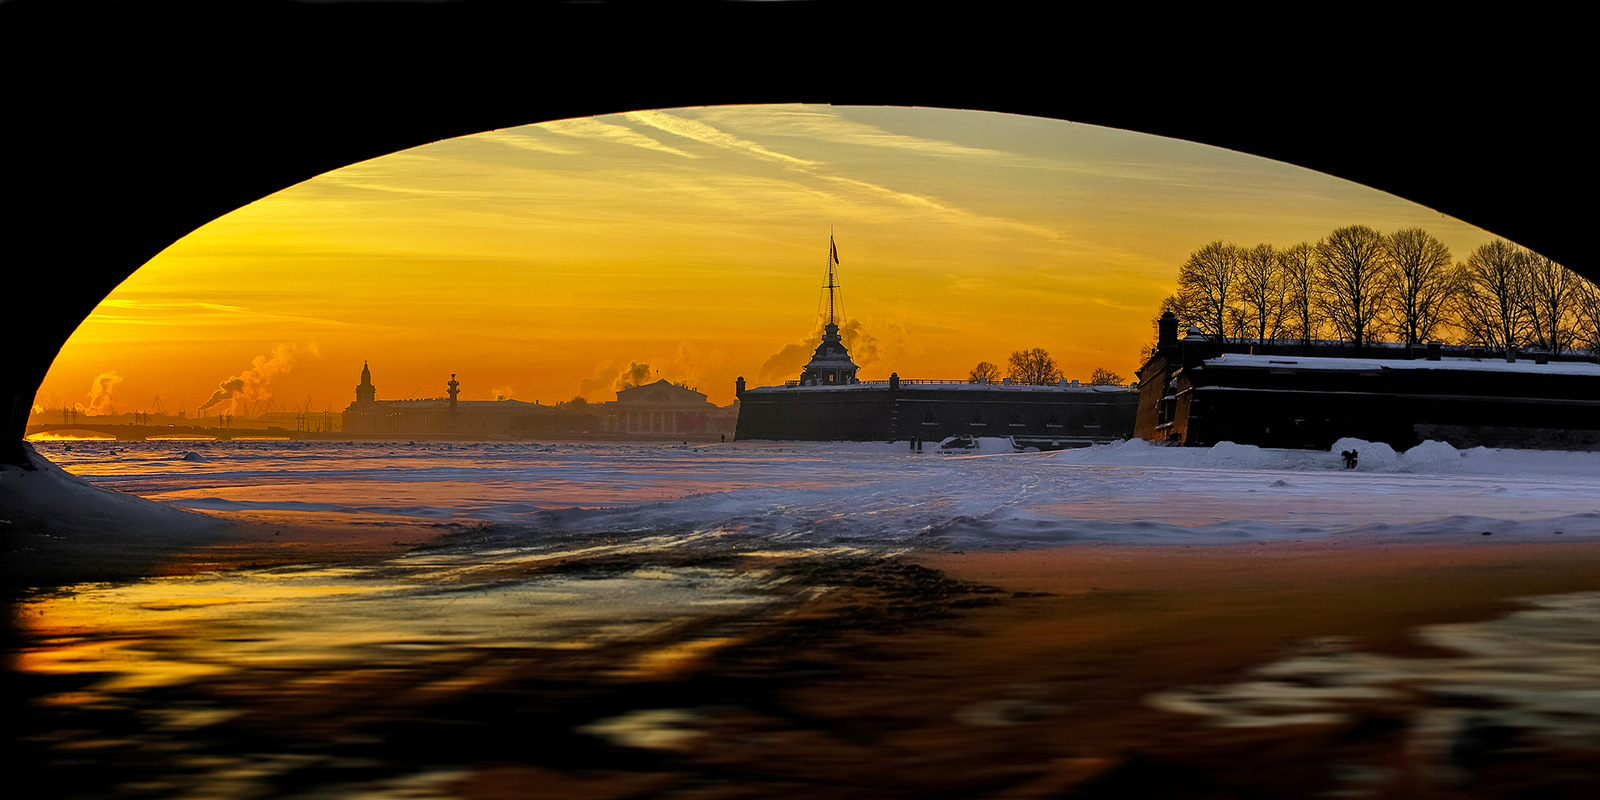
[1134,315,1600,450]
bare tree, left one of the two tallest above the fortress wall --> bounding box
[1317,226,1392,355]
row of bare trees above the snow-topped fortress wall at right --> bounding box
[1162,226,1600,355]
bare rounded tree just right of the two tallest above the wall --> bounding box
[1456,238,1533,349]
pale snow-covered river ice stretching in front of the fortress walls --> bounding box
[21,438,1600,549]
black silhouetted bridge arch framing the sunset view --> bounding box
[0,2,1600,462]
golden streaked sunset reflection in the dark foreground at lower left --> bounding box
[19,549,806,701]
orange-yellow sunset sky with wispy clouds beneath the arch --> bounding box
[35,106,1493,416]
